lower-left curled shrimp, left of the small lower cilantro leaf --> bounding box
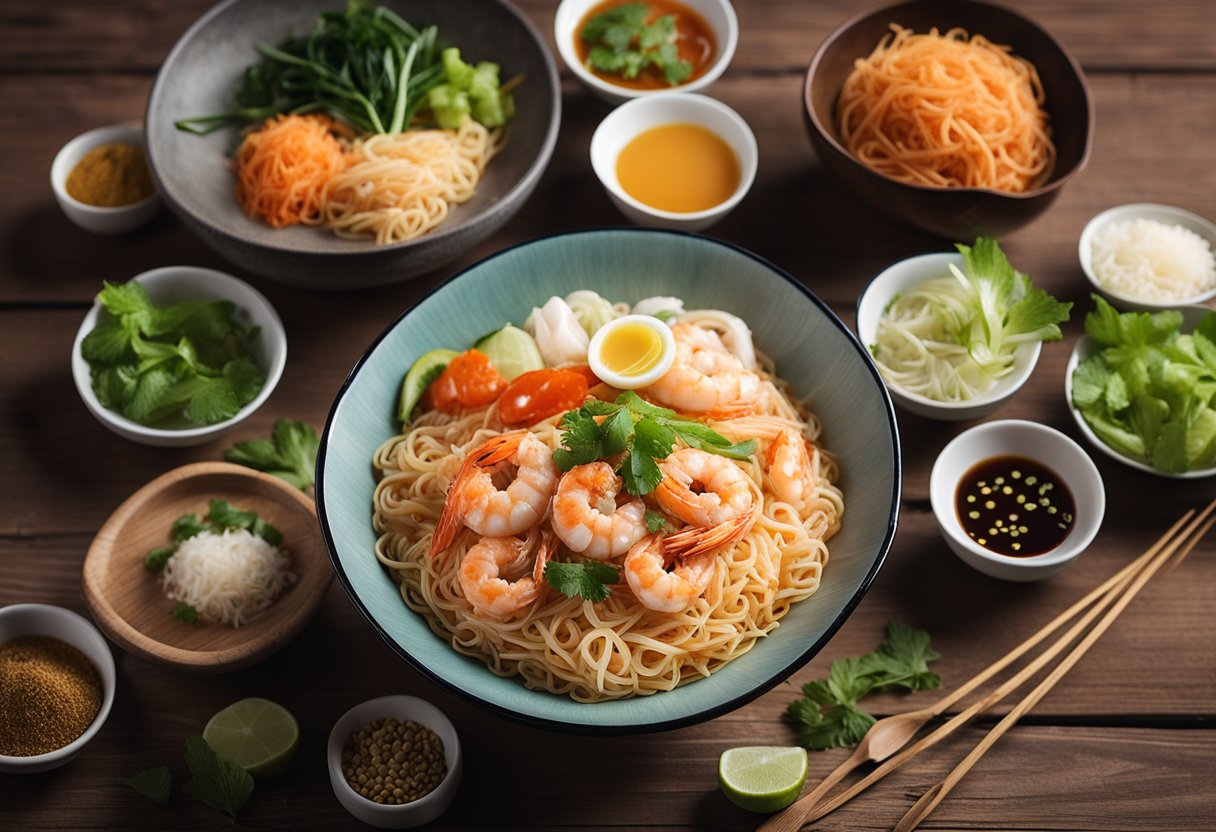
[460,534,553,615]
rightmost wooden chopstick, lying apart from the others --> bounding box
[895,500,1216,832]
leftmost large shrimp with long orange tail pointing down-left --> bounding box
[430,431,558,556]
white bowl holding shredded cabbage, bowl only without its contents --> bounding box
[855,252,1042,421]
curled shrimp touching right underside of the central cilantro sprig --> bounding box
[654,448,755,525]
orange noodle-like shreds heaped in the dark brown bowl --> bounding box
[837,24,1055,193]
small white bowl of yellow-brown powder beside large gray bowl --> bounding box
[51,122,161,234]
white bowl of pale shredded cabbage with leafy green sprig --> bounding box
[856,237,1073,421]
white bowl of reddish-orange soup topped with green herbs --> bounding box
[553,0,739,105]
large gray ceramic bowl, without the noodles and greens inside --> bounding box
[145,0,562,289]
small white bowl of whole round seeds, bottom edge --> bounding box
[328,696,461,830]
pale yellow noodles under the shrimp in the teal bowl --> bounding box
[373,357,844,702]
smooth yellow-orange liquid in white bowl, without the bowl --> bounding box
[617,124,739,214]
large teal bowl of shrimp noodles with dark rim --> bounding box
[316,229,900,733]
